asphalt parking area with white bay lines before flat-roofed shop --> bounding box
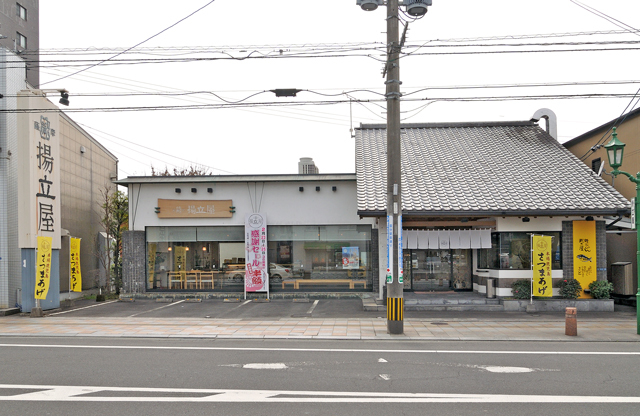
[46,299,386,320]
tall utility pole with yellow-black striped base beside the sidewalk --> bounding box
[385,0,404,334]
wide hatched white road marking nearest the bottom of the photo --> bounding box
[0,384,640,404]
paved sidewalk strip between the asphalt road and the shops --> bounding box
[0,315,640,342]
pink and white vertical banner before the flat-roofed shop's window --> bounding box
[244,213,269,292]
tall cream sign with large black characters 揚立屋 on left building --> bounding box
[18,90,61,249]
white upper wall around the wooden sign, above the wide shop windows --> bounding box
[129,180,375,231]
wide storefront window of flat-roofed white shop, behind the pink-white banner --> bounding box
[146,225,373,291]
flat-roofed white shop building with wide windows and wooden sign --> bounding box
[117,174,378,293]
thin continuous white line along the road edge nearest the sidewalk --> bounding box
[0,344,640,356]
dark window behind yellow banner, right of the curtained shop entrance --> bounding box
[478,232,562,270]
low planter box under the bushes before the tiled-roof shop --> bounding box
[501,299,613,312]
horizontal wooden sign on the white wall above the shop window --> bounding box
[156,199,235,218]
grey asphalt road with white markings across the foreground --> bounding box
[0,337,640,416]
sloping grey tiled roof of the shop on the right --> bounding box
[356,121,630,216]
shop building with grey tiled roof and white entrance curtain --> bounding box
[356,117,630,296]
